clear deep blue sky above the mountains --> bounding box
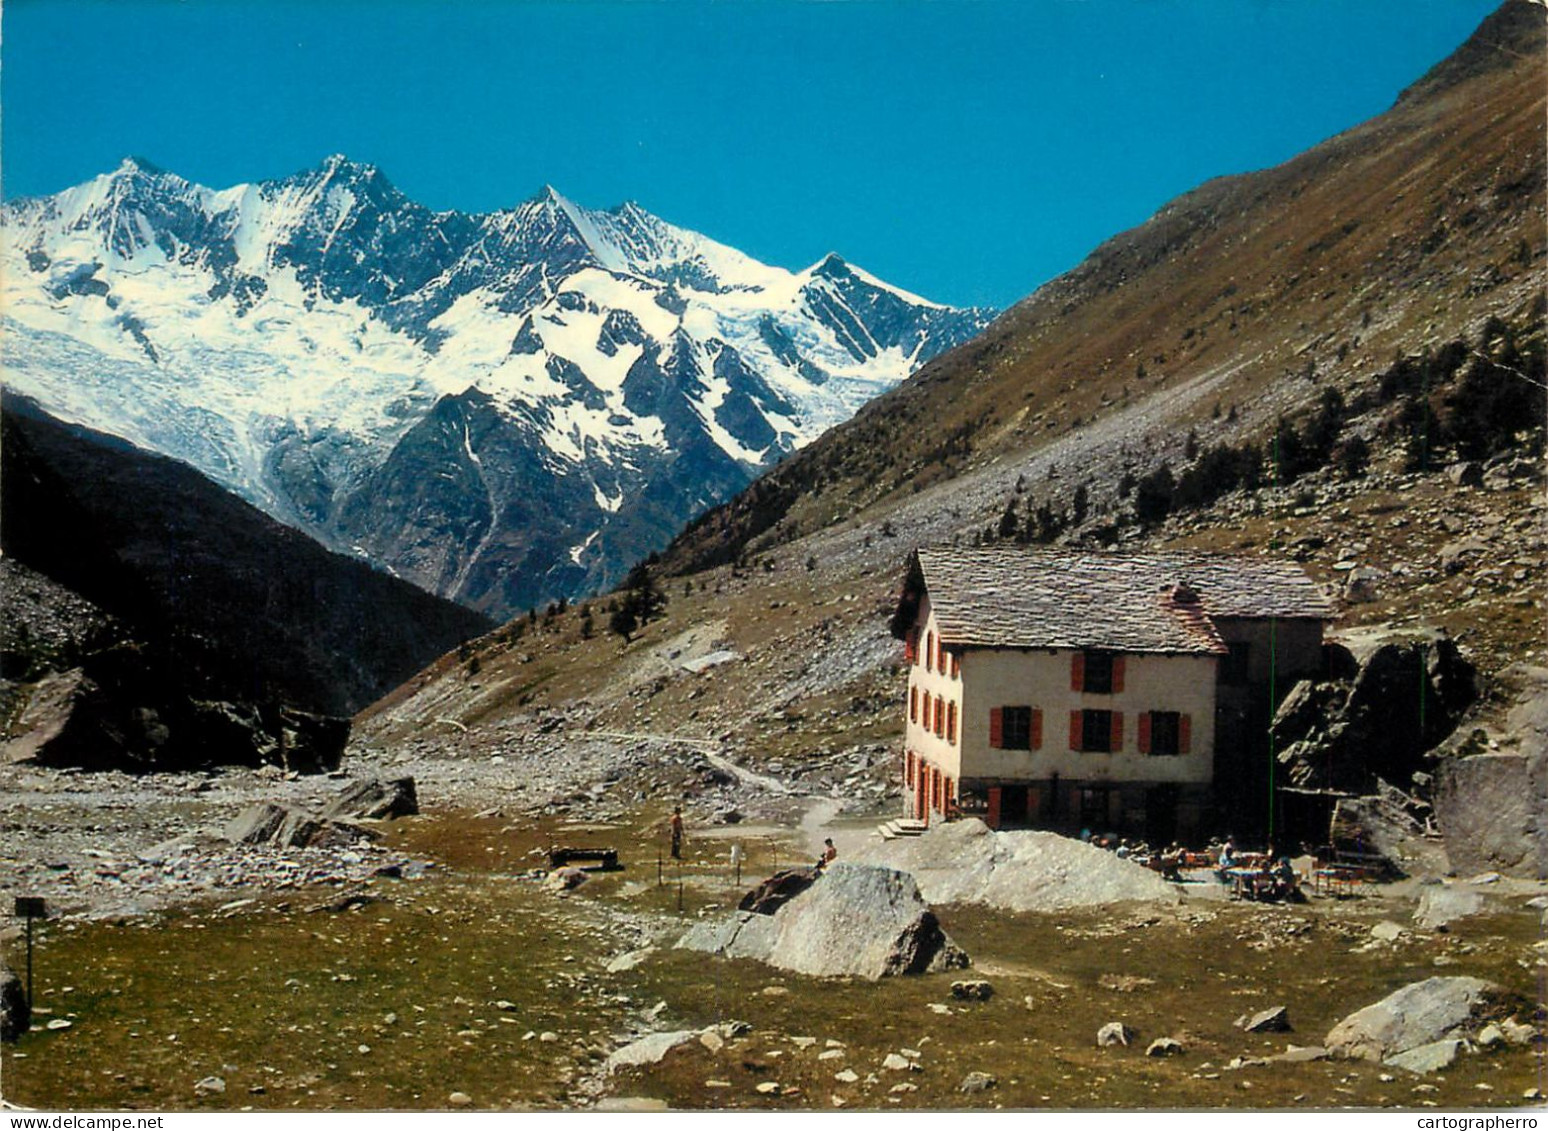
[0,0,1495,305]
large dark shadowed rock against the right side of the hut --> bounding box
[1271,630,1478,795]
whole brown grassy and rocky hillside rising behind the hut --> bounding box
[358,0,1548,774]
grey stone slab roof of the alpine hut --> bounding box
[918,546,1334,654]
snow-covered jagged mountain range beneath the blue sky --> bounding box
[0,156,988,616]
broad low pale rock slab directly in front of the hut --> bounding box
[861,818,1181,911]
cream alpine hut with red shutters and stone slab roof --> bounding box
[892,546,1333,843]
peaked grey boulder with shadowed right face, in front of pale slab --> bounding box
[678,863,968,978]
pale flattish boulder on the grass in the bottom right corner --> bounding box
[1324,978,1505,1060]
